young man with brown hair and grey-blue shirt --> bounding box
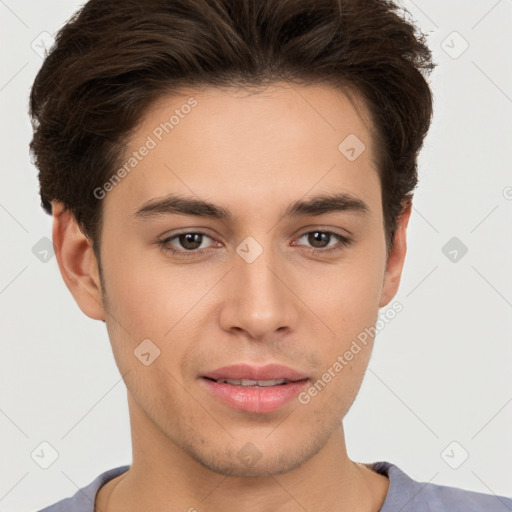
[30,0,512,512]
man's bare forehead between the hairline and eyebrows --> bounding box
[102,84,378,220]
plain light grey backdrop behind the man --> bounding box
[0,0,512,512]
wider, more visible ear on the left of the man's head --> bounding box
[52,201,105,320]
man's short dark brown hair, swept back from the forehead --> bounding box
[30,0,434,258]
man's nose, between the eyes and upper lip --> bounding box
[220,241,300,340]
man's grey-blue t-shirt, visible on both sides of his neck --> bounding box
[39,461,512,512]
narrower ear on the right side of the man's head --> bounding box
[379,201,412,308]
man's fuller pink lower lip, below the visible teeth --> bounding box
[201,377,308,413]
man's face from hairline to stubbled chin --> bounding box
[56,85,404,476]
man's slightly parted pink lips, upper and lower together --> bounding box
[200,364,309,414]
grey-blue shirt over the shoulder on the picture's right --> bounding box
[366,462,512,512]
